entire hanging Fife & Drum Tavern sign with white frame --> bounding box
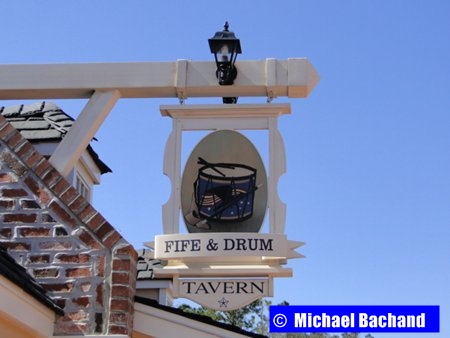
[147,104,303,310]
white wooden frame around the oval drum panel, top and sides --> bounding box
[160,103,291,234]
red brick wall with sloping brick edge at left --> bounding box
[0,116,137,335]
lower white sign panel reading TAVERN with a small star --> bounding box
[173,277,273,311]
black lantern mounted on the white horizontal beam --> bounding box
[208,22,242,103]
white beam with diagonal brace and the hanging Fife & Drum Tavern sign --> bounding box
[0,56,319,310]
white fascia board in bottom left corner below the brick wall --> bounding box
[0,276,55,337]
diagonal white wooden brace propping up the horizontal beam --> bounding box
[49,90,120,176]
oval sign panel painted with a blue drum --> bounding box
[181,130,267,232]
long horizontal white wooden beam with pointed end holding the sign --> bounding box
[0,58,319,100]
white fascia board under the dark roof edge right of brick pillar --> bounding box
[133,303,253,338]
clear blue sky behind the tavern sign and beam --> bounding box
[0,0,450,337]
